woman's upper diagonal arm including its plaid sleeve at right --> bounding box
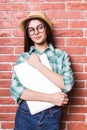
[27,53,74,92]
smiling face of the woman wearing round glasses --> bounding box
[28,19,47,44]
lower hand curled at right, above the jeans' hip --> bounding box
[50,92,69,106]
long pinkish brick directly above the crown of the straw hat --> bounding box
[29,3,65,10]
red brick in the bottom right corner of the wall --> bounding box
[68,122,87,130]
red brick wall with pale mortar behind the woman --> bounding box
[0,0,87,130]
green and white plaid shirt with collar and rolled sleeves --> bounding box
[10,44,74,101]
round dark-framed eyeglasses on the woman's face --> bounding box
[28,24,45,35]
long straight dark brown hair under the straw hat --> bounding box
[24,18,54,52]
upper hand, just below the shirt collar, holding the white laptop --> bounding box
[27,53,41,69]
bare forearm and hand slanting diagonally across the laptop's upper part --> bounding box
[27,53,64,89]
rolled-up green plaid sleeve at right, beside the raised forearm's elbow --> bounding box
[62,52,74,92]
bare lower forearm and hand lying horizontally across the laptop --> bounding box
[20,89,68,106]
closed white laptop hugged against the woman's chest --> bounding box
[14,54,61,115]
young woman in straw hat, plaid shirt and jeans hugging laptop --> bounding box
[10,11,74,130]
